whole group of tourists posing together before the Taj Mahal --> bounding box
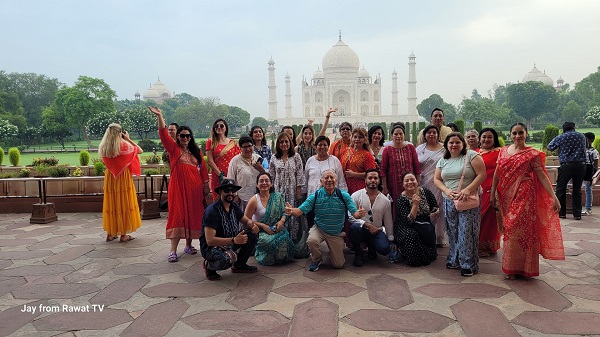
[96,108,564,280]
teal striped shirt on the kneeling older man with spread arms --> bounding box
[298,187,358,235]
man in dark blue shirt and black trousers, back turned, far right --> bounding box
[548,122,587,220]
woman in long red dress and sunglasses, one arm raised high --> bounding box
[149,107,209,262]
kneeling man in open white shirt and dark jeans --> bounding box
[348,169,394,267]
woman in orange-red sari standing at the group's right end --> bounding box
[491,123,565,279]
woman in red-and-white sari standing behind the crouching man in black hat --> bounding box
[206,118,240,201]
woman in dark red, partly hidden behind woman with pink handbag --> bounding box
[478,128,501,257]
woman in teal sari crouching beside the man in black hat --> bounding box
[244,172,296,266]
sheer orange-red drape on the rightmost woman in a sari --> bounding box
[496,147,565,260]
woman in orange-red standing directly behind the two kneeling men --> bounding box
[342,128,377,194]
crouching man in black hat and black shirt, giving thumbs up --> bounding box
[200,179,258,281]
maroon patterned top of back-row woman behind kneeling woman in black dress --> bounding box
[381,143,421,203]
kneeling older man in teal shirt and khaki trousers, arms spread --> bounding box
[285,170,366,271]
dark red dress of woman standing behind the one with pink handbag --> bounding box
[477,148,500,253]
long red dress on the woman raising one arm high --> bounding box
[158,128,208,239]
